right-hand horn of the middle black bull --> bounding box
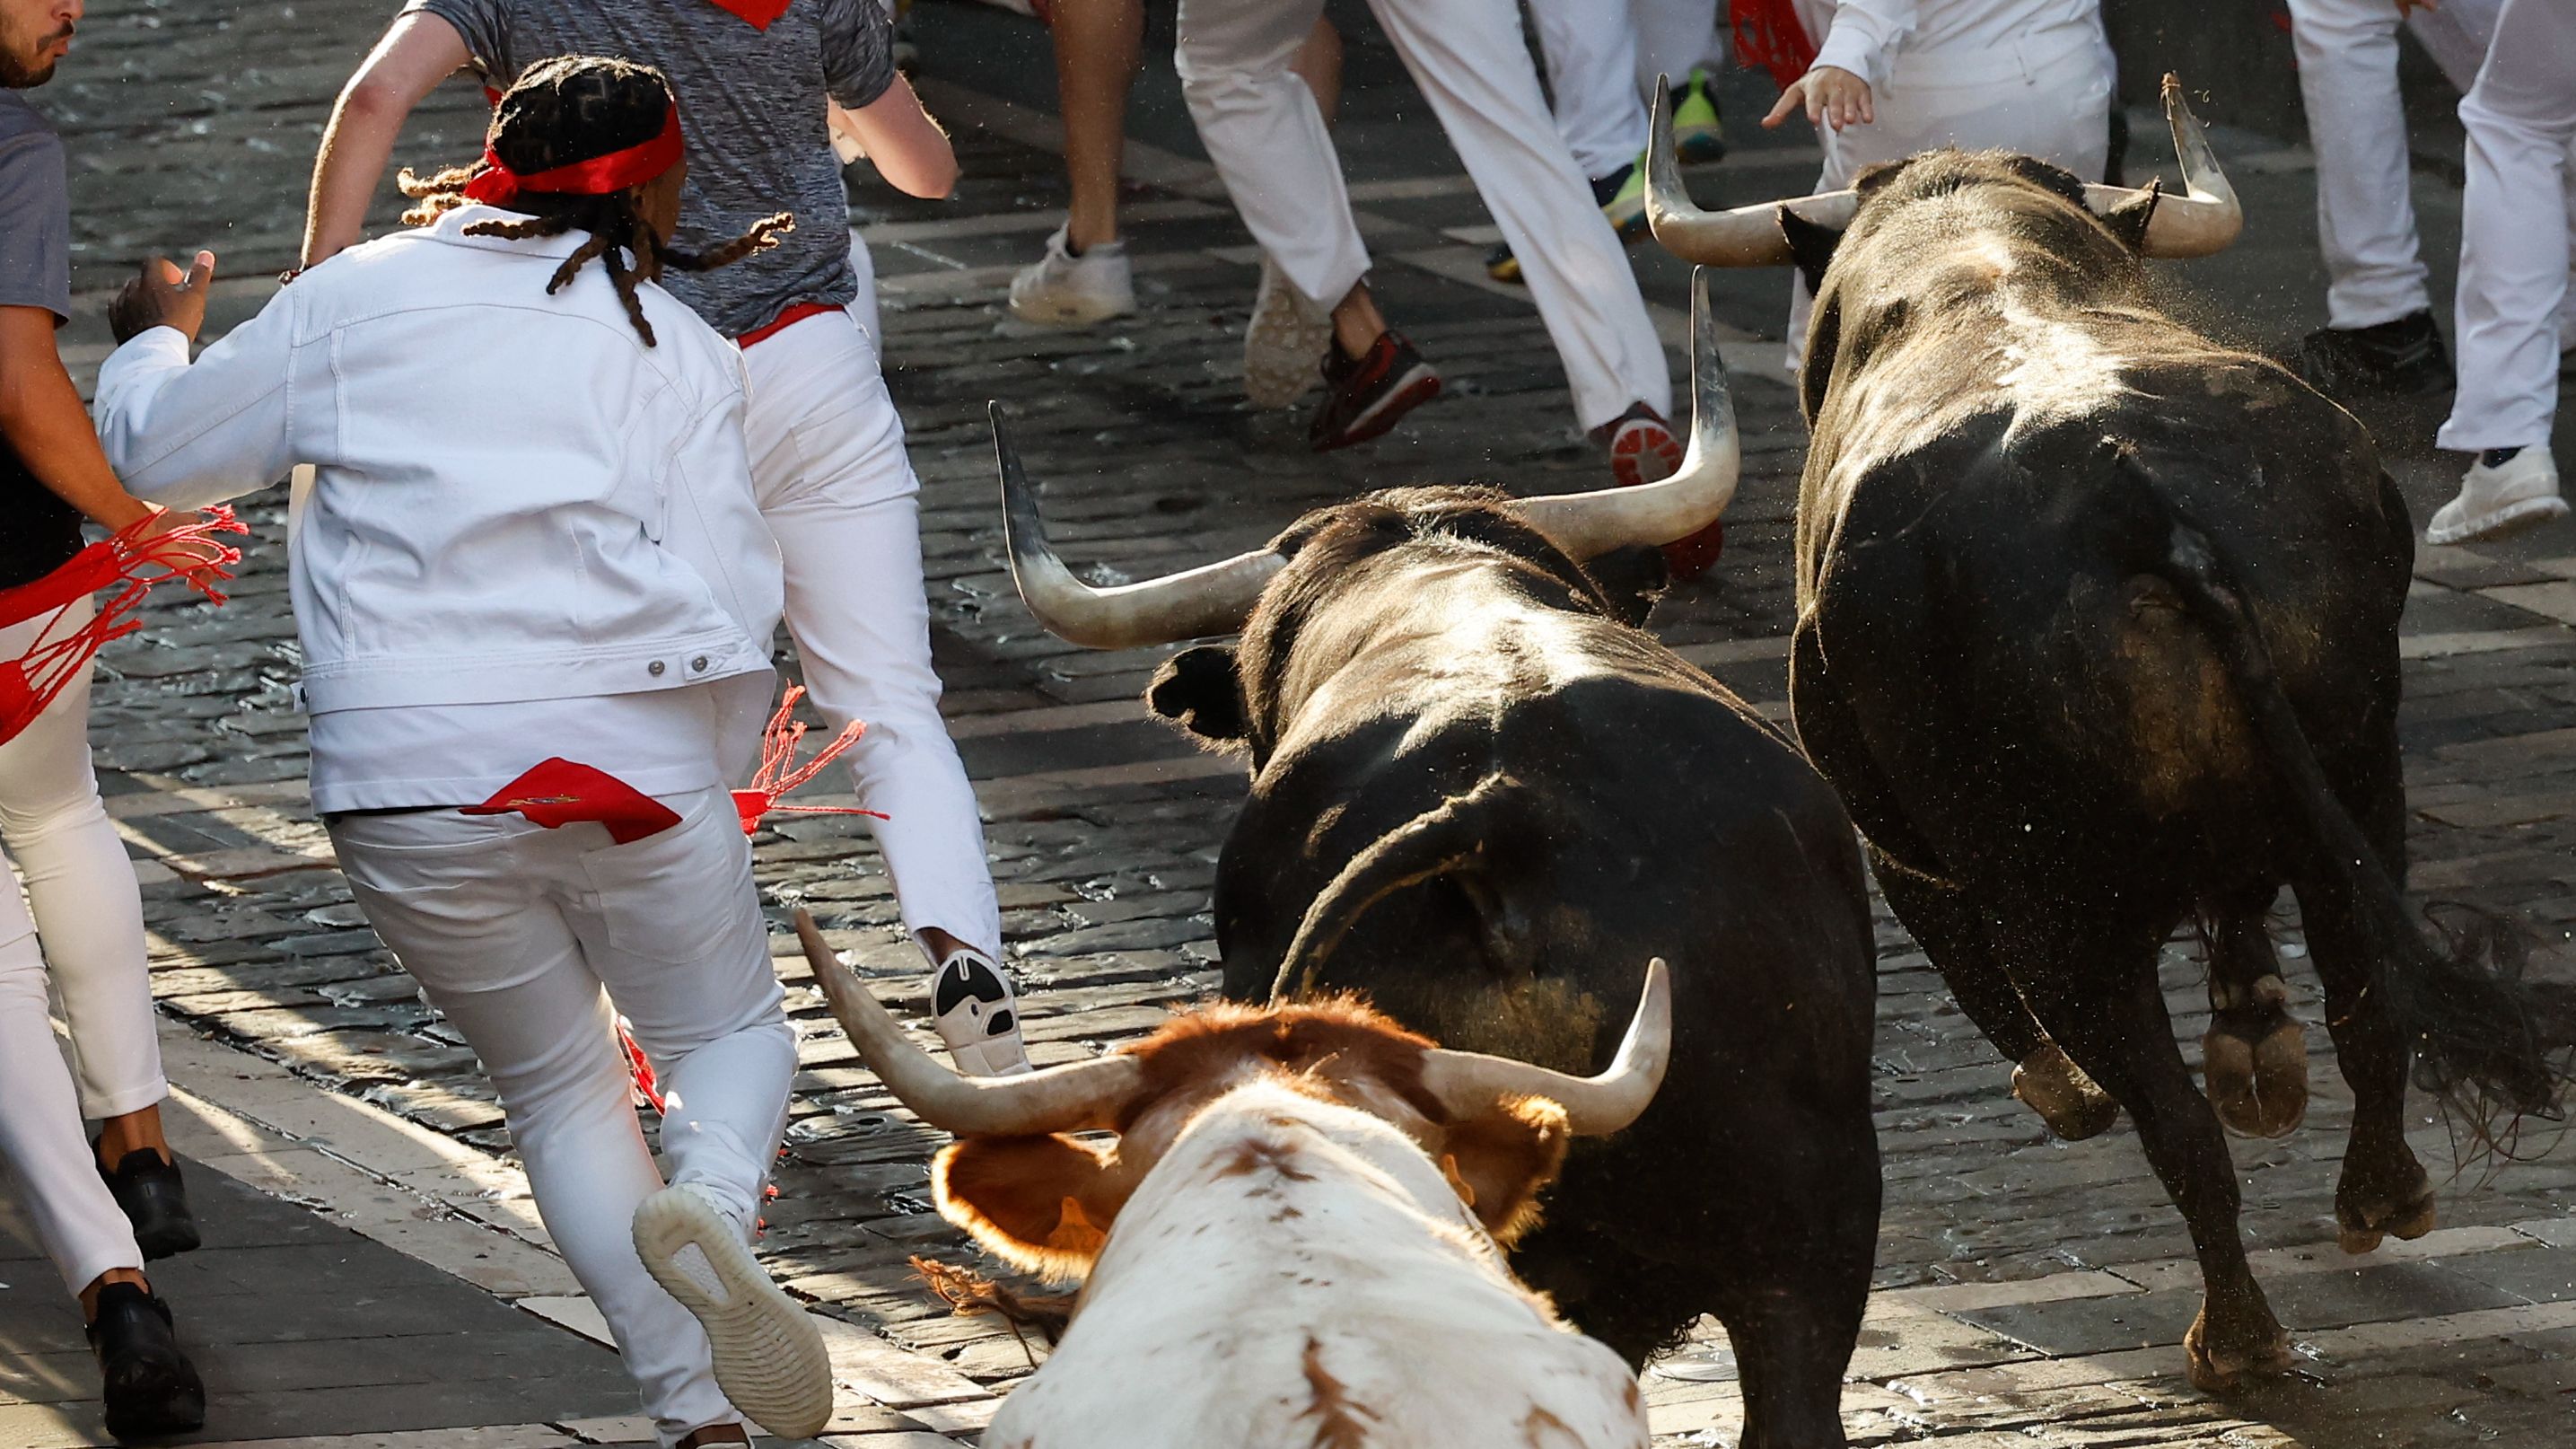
[1515,268,1744,559]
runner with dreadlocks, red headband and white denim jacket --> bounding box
[98,57,832,1449]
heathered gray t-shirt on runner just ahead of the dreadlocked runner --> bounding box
[405,0,894,338]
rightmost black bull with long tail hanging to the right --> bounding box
[1785,152,2555,1387]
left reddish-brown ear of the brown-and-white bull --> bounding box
[930,1135,1126,1281]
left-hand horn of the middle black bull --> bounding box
[992,402,1285,650]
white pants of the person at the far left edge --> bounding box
[0,601,155,1295]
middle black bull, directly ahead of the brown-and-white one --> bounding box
[1002,287,1878,1446]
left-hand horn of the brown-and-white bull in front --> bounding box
[796,910,1143,1137]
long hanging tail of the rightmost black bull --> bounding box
[2123,453,2568,1119]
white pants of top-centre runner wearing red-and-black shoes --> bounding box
[1179,0,1672,427]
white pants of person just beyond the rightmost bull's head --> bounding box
[1788,23,2112,376]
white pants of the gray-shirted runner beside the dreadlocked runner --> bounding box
[742,312,1002,959]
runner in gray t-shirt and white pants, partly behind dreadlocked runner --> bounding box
[304,0,1028,1073]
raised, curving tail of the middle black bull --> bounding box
[1270,771,1536,997]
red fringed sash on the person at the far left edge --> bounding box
[0,508,250,742]
